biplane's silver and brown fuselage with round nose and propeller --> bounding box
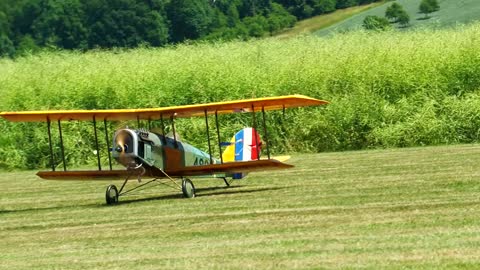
[112,128,220,170]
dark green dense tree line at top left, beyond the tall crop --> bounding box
[0,0,380,57]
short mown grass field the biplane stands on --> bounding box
[0,145,480,269]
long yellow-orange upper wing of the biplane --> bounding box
[0,95,328,122]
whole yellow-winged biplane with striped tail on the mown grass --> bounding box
[0,95,328,204]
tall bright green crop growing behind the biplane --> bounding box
[0,24,480,168]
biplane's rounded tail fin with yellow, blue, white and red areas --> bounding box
[222,127,262,179]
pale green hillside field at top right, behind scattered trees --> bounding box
[315,0,480,35]
